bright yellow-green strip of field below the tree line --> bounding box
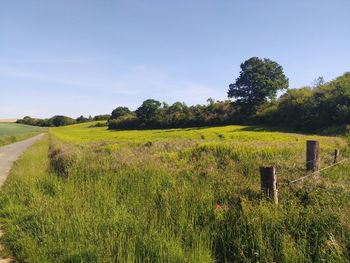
[51,122,340,145]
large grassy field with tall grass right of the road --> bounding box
[0,123,350,262]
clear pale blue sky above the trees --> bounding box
[0,0,350,118]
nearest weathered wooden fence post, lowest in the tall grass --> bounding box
[260,166,278,205]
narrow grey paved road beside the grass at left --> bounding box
[0,133,44,187]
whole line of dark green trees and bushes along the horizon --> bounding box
[18,57,350,132]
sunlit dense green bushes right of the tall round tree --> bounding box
[257,73,350,131]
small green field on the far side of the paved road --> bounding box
[0,123,43,146]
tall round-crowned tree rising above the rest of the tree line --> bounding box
[227,57,289,115]
